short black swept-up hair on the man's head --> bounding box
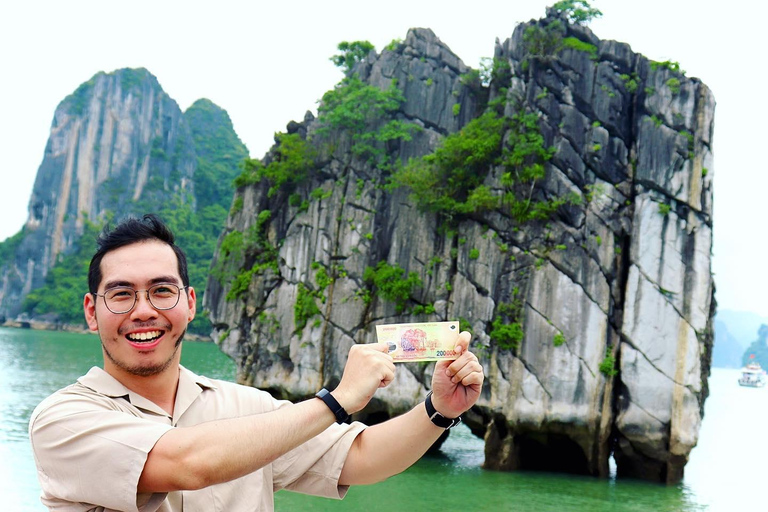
[88,213,189,293]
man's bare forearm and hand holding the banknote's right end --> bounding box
[339,332,484,485]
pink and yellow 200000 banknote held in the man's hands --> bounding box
[376,322,459,363]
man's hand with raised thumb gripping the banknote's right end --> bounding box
[432,331,484,418]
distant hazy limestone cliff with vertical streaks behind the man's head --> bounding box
[0,69,247,321]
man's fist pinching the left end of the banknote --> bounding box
[331,343,395,414]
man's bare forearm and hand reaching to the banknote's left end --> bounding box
[138,344,394,492]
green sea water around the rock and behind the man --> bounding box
[0,327,756,512]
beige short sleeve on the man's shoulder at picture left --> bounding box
[29,397,173,510]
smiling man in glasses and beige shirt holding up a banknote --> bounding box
[29,215,483,512]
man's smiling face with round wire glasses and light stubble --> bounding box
[83,240,195,377]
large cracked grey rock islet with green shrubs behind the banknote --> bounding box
[205,13,715,482]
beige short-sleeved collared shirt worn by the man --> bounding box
[29,367,365,512]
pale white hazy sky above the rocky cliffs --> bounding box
[0,0,768,317]
